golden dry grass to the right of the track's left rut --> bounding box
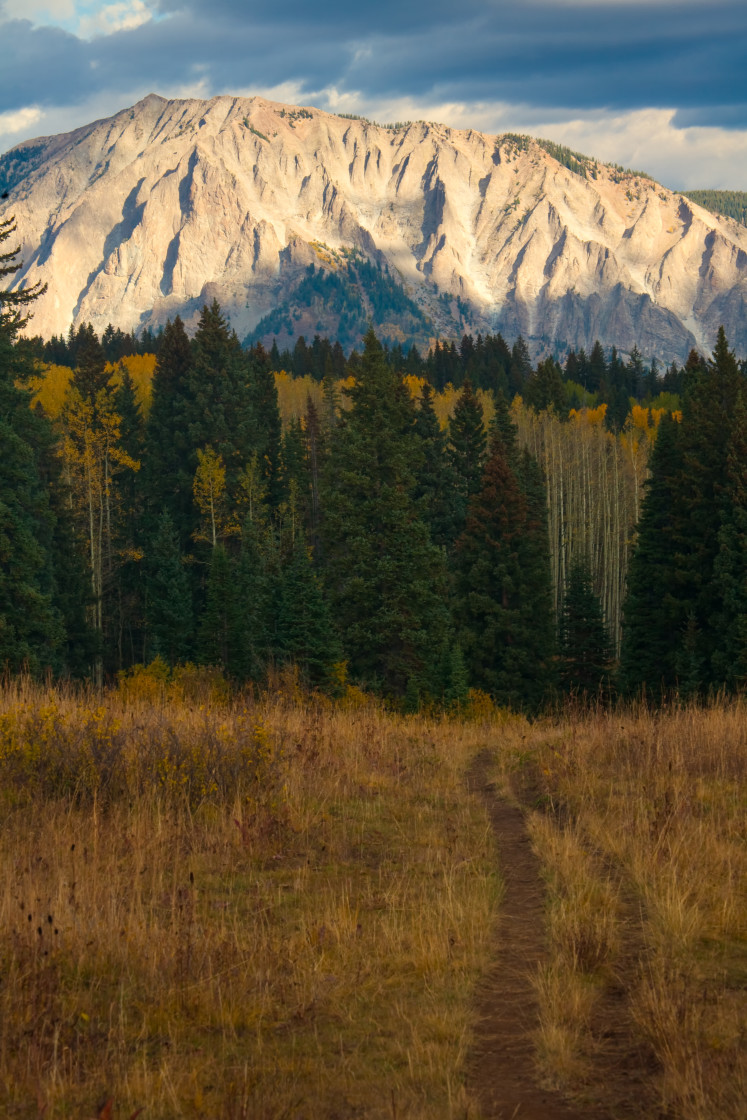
[492,703,747,1120]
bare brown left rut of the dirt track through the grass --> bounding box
[468,752,609,1120]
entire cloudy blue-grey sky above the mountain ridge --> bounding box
[0,0,747,189]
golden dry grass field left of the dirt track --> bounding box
[0,688,497,1120]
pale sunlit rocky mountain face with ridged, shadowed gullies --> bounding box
[0,95,747,361]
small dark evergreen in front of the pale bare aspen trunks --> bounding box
[559,561,611,697]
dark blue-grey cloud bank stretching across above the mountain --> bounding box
[0,0,747,128]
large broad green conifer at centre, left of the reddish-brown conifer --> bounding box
[323,330,448,697]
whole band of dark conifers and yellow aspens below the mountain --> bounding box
[0,210,747,712]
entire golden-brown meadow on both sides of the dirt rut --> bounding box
[0,670,747,1120]
